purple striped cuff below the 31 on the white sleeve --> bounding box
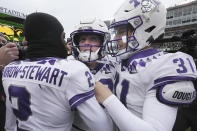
[150,76,195,90]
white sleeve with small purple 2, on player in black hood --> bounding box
[66,62,95,110]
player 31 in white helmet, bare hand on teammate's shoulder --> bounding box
[95,0,197,131]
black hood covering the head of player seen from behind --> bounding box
[24,12,67,59]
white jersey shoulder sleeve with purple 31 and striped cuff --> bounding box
[143,52,197,89]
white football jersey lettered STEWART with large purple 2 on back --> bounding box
[2,58,112,131]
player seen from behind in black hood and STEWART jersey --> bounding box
[2,12,112,131]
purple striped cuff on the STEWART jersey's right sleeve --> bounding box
[69,90,94,111]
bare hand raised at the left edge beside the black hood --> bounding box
[0,42,19,66]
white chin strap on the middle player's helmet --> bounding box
[79,48,100,62]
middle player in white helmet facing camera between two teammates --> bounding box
[70,19,114,131]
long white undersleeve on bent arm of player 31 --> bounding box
[103,87,177,131]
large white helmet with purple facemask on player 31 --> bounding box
[107,0,167,59]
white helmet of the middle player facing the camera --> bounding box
[70,19,110,62]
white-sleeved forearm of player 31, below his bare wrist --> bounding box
[103,95,156,131]
